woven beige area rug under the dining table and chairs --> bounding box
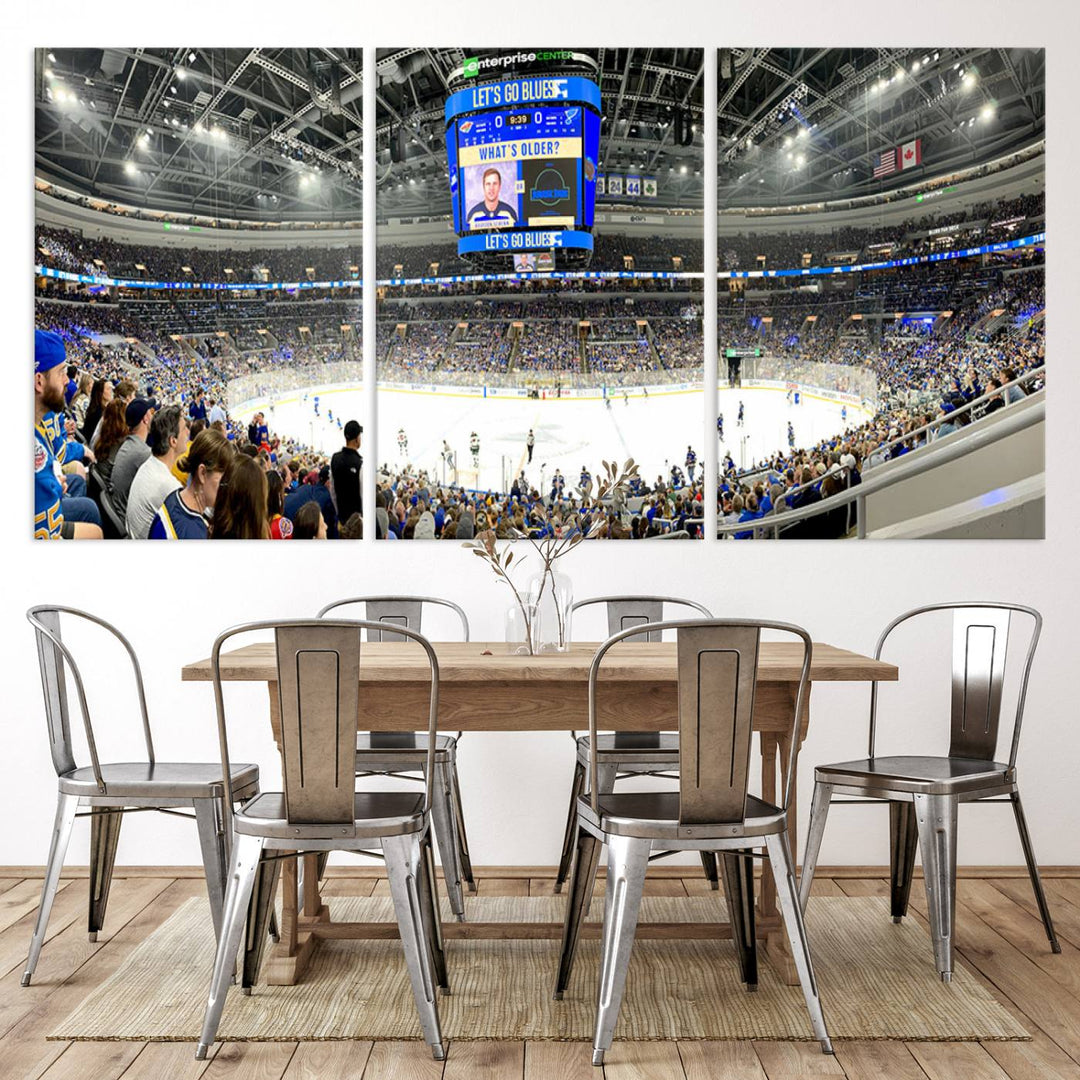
[49,896,1030,1041]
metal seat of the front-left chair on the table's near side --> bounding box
[233,792,424,840]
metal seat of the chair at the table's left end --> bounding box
[59,761,259,799]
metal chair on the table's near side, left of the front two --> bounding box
[195,619,449,1061]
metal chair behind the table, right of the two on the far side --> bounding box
[555,596,720,892]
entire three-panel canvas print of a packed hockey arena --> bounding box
[32,46,1045,540]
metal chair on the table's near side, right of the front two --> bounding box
[555,619,833,1065]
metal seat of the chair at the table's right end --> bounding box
[814,756,1015,795]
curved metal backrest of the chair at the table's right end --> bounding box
[869,600,1042,766]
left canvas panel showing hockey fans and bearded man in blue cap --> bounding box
[33,48,363,539]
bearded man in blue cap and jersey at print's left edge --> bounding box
[33,330,102,540]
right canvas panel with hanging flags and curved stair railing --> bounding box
[716,48,1047,539]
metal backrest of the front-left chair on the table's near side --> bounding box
[211,619,438,826]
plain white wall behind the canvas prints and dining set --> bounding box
[6,0,1080,865]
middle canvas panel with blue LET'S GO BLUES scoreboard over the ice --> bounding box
[376,49,705,540]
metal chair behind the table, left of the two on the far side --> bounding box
[319,596,476,921]
